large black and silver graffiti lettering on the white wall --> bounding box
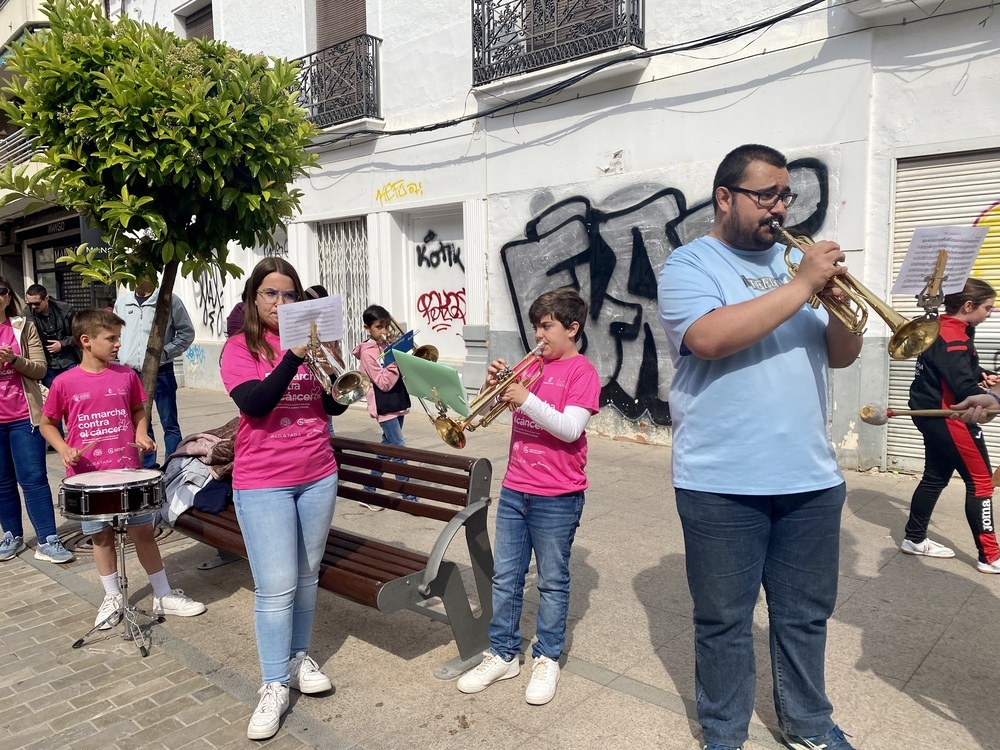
[500,158,829,425]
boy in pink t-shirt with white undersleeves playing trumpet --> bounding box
[458,288,601,706]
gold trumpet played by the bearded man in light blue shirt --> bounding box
[769,219,941,359]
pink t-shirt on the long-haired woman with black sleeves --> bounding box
[222,333,337,490]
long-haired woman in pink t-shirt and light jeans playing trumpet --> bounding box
[222,257,347,740]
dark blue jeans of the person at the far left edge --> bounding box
[0,419,56,542]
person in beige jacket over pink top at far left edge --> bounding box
[0,277,73,563]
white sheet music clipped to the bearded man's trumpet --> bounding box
[892,227,989,294]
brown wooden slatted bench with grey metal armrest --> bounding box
[174,437,493,679]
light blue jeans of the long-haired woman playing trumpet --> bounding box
[233,472,337,685]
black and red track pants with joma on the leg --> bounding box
[906,417,1000,563]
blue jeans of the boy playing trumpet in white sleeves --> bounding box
[490,487,584,661]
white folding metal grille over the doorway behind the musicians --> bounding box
[316,218,369,362]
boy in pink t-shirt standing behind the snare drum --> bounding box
[40,309,205,630]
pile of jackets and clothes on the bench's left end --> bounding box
[160,417,239,526]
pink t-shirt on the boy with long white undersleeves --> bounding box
[503,354,601,497]
